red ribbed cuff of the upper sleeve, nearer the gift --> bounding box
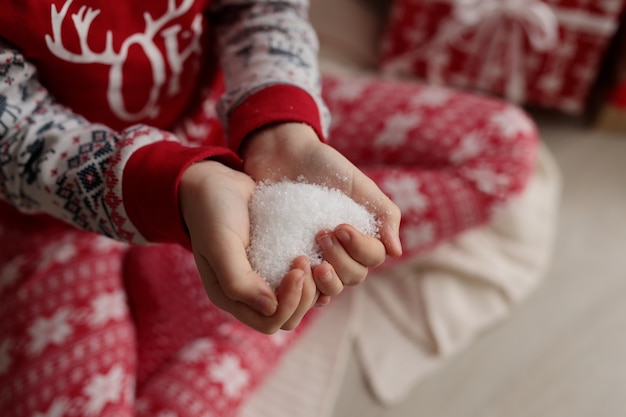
[228,84,324,152]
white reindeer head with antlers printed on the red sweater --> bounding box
[45,0,202,122]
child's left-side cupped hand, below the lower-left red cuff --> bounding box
[179,161,317,333]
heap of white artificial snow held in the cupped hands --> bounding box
[248,181,378,288]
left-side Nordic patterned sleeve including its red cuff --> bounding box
[0,43,239,246]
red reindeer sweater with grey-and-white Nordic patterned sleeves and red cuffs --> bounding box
[0,0,328,246]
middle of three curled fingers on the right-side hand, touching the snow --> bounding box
[316,231,367,285]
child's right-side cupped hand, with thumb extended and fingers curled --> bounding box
[242,123,402,296]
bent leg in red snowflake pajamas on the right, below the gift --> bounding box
[323,77,538,264]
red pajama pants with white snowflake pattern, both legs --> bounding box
[0,78,537,417]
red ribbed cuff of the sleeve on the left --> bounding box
[122,142,241,248]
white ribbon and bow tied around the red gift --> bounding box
[386,0,617,103]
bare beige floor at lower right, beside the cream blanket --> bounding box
[334,115,626,417]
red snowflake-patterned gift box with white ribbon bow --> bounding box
[381,0,626,114]
